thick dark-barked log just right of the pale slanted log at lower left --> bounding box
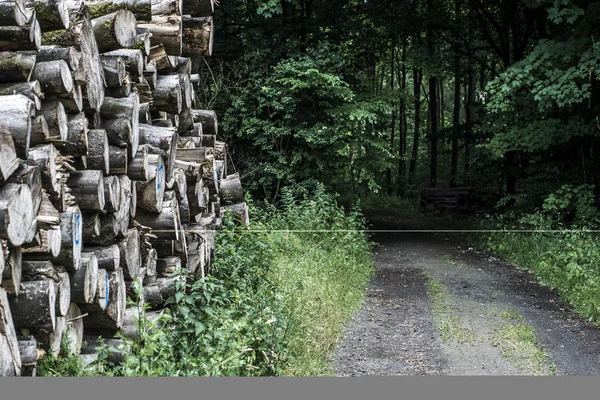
[8,279,56,329]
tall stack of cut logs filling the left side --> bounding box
[0,0,248,376]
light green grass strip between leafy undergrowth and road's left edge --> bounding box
[272,234,371,376]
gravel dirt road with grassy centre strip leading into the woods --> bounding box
[333,233,600,376]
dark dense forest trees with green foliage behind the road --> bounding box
[200,0,600,212]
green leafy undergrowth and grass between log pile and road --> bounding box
[38,186,372,376]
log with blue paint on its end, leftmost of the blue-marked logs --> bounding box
[55,206,83,272]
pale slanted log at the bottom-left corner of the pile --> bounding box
[0,287,21,376]
